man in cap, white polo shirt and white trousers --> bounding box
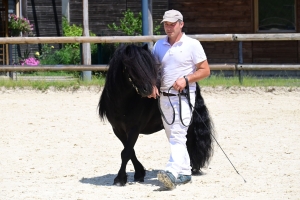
[148,10,210,189]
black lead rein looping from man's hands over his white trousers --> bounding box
[158,76,193,127]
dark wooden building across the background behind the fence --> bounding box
[0,0,300,63]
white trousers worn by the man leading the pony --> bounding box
[160,92,195,177]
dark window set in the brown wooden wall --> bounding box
[254,0,296,33]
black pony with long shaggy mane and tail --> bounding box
[98,45,213,186]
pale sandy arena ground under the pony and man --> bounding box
[0,87,300,200]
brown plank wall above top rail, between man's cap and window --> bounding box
[169,0,253,34]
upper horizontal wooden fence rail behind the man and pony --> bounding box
[0,33,300,44]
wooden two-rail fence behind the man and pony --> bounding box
[0,33,300,81]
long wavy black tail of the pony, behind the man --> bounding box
[187,83,214,174]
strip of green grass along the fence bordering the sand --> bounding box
[0,74,300,91]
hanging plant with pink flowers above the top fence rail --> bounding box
[8,14,33,35]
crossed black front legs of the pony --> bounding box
[114,130,145,186]
